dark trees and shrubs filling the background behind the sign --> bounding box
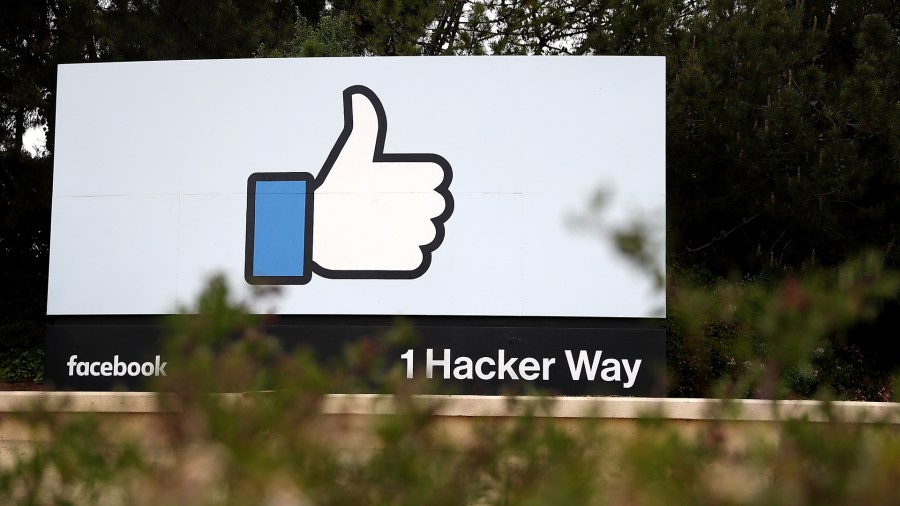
[0,0,900,401]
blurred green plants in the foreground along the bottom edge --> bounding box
[0,278,900,506]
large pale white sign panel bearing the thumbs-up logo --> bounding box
[47,57,665,317]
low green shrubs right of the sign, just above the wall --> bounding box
[668,253,900,401]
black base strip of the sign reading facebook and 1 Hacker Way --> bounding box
[44,316,666,397]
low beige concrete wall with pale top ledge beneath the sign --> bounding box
[0,392,900,452]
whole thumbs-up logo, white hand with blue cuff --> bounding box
[244,86,453,285]
